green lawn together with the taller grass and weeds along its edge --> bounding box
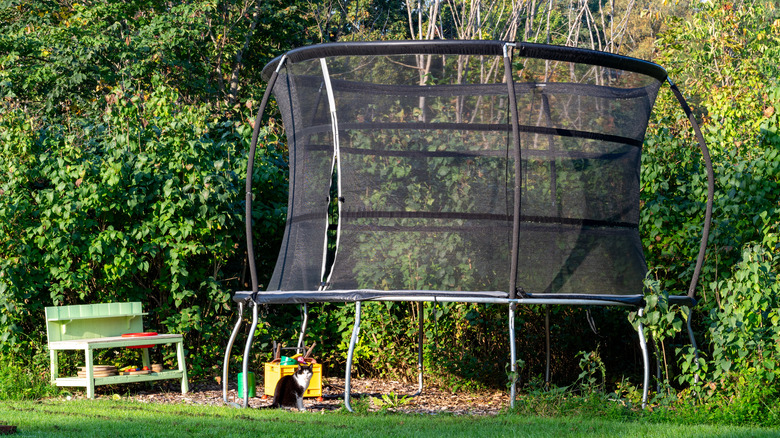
[0,361,780,438]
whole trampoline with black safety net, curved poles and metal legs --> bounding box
[222,40,714,410]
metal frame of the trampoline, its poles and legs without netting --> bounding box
[222,42,714,411]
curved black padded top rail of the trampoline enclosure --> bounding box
[263,40,667,81]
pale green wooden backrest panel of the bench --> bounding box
[46,302,146,342]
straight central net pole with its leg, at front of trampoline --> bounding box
[504,44,522,407]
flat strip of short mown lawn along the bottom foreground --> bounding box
[0,399,778,438]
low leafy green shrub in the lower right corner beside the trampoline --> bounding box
[679,246,780,424]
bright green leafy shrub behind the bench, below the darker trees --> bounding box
[0,84,286,375]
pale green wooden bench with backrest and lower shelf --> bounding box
[46,302,189,398]
